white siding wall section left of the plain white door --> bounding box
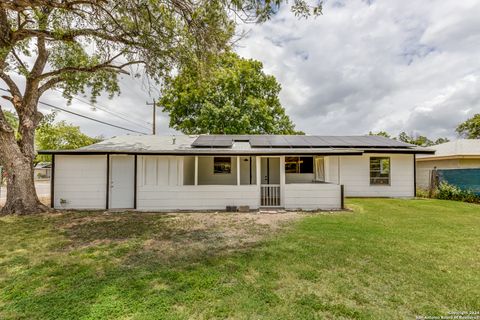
[54,155,107,209]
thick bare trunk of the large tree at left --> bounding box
[0,126,49,215]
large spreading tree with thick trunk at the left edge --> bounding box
[0,0,320,214]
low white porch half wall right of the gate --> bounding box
[284,183,341,210]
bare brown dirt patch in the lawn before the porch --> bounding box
[58,212,307,262]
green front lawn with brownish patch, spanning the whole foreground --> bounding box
[0,199,480,319]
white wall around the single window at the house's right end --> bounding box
[326,153,415,198]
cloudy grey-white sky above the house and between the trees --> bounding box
[11,0,480,138]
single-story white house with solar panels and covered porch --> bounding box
[39,135,433,211]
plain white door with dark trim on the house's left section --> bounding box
[110,155,135,209]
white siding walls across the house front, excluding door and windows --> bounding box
[51,154,414,211]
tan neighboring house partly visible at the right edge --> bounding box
[417,139,480,189]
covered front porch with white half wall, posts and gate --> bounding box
[133,155,343,210]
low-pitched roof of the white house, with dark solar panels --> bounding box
[38,135,433,155]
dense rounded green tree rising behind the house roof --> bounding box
[159,53,296,134]
